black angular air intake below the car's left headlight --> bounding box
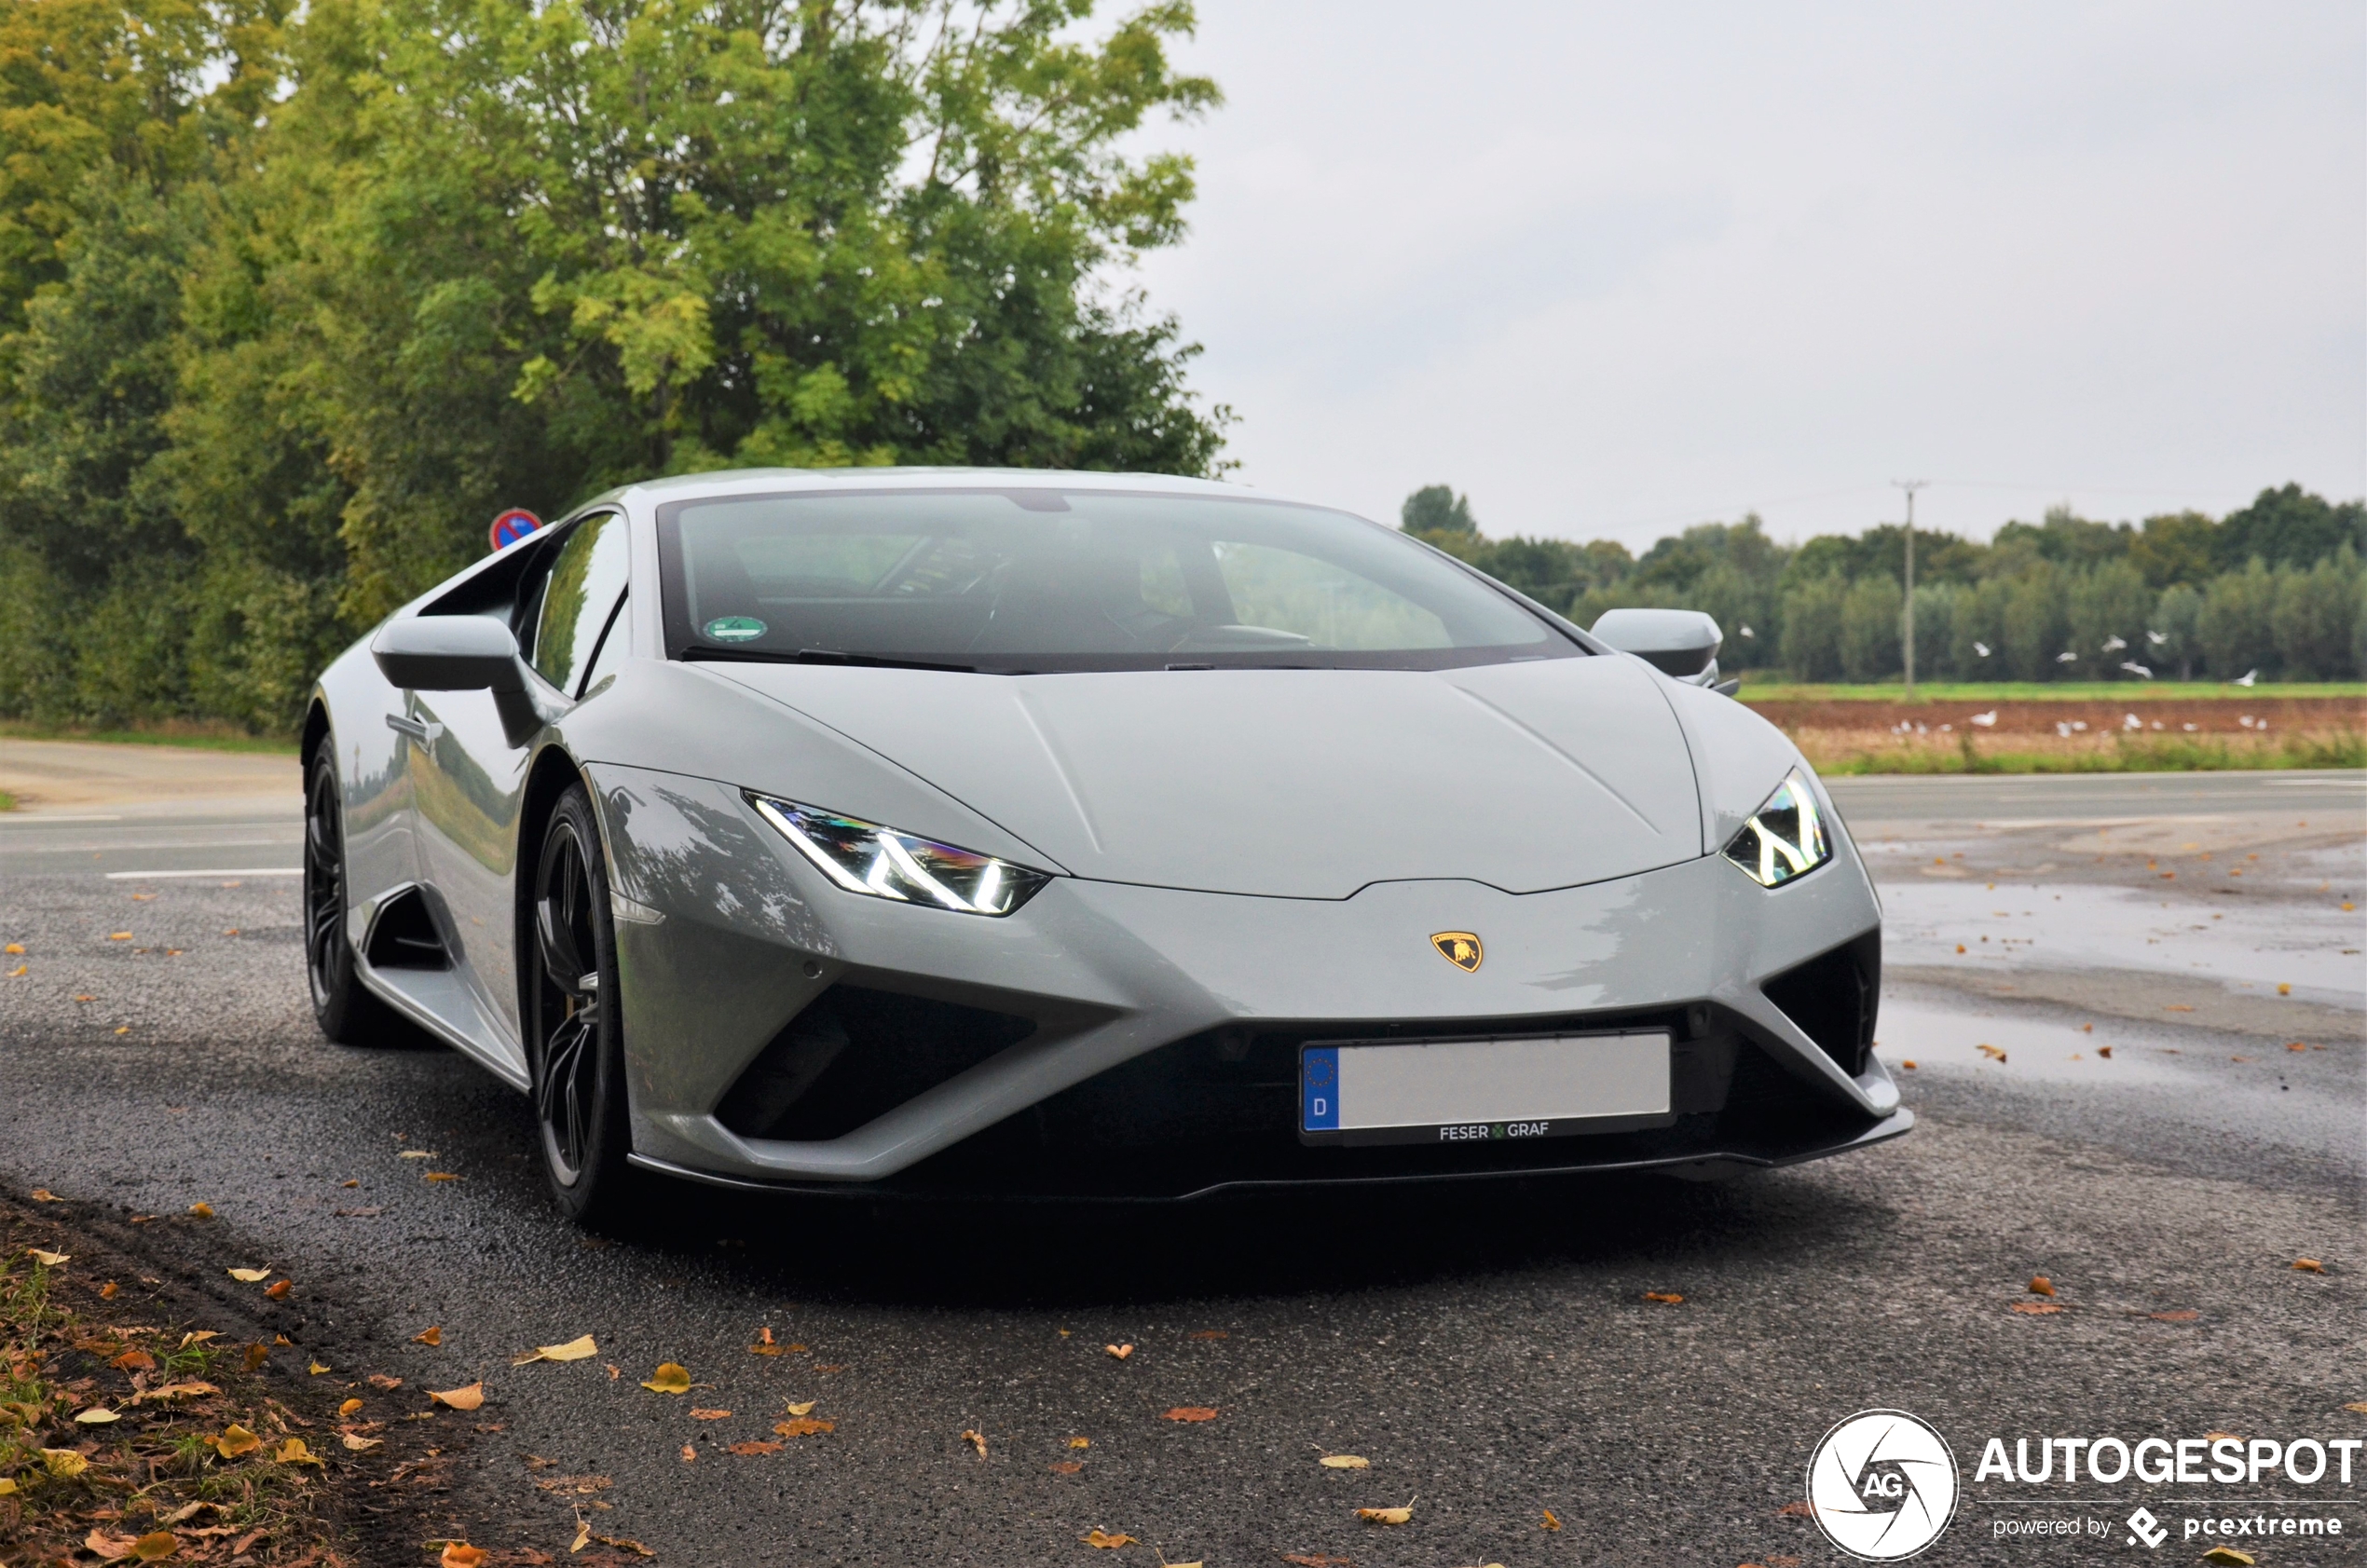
[715,987,1034,1142]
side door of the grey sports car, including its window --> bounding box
[412,513,627,1071]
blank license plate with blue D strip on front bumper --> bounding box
[1299,1029,1676,1142]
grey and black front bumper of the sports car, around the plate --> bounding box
[587,764,1912,1196]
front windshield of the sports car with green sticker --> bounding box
[658,487,1583,674]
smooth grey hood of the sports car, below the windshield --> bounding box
[705,658,1702,899]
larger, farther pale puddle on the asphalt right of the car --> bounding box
[1881,882,2367,1010]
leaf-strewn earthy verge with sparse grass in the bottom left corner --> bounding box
[0,1213,343,1568]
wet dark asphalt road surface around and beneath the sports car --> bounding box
[0,776,2367,1568]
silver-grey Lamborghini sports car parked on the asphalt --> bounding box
[303,469,1912,1222]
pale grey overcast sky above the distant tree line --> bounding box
[1141,0,2367,549]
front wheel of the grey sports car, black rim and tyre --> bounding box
[527,783,639,1225]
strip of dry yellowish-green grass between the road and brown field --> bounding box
[1794,730,2367,773]
